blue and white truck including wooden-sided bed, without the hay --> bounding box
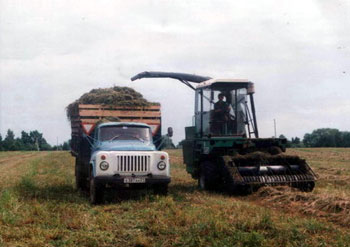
[70,104,171,204]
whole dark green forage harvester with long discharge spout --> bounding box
[131,72,317,192]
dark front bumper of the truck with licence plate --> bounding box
[95,175,171,186]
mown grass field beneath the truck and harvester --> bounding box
[0,149,350,247]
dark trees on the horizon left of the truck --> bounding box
[0,129,70,151]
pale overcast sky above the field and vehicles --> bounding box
[0,0,350,145]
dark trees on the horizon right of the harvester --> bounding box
[280,128,350,147]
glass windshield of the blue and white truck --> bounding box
[99,126,152,142]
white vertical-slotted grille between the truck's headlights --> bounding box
[117,155,151,172]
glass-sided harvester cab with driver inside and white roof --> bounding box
[194,79,258,137]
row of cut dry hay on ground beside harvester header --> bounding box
[257,186,350,227]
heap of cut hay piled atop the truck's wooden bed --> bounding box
[66,86,159,120]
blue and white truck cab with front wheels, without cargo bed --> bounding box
[82,122,171,204]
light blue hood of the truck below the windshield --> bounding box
[92,140,156,152]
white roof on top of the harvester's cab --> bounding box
[197,79,254,93]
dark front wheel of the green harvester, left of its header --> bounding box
[198,160,220,190]
